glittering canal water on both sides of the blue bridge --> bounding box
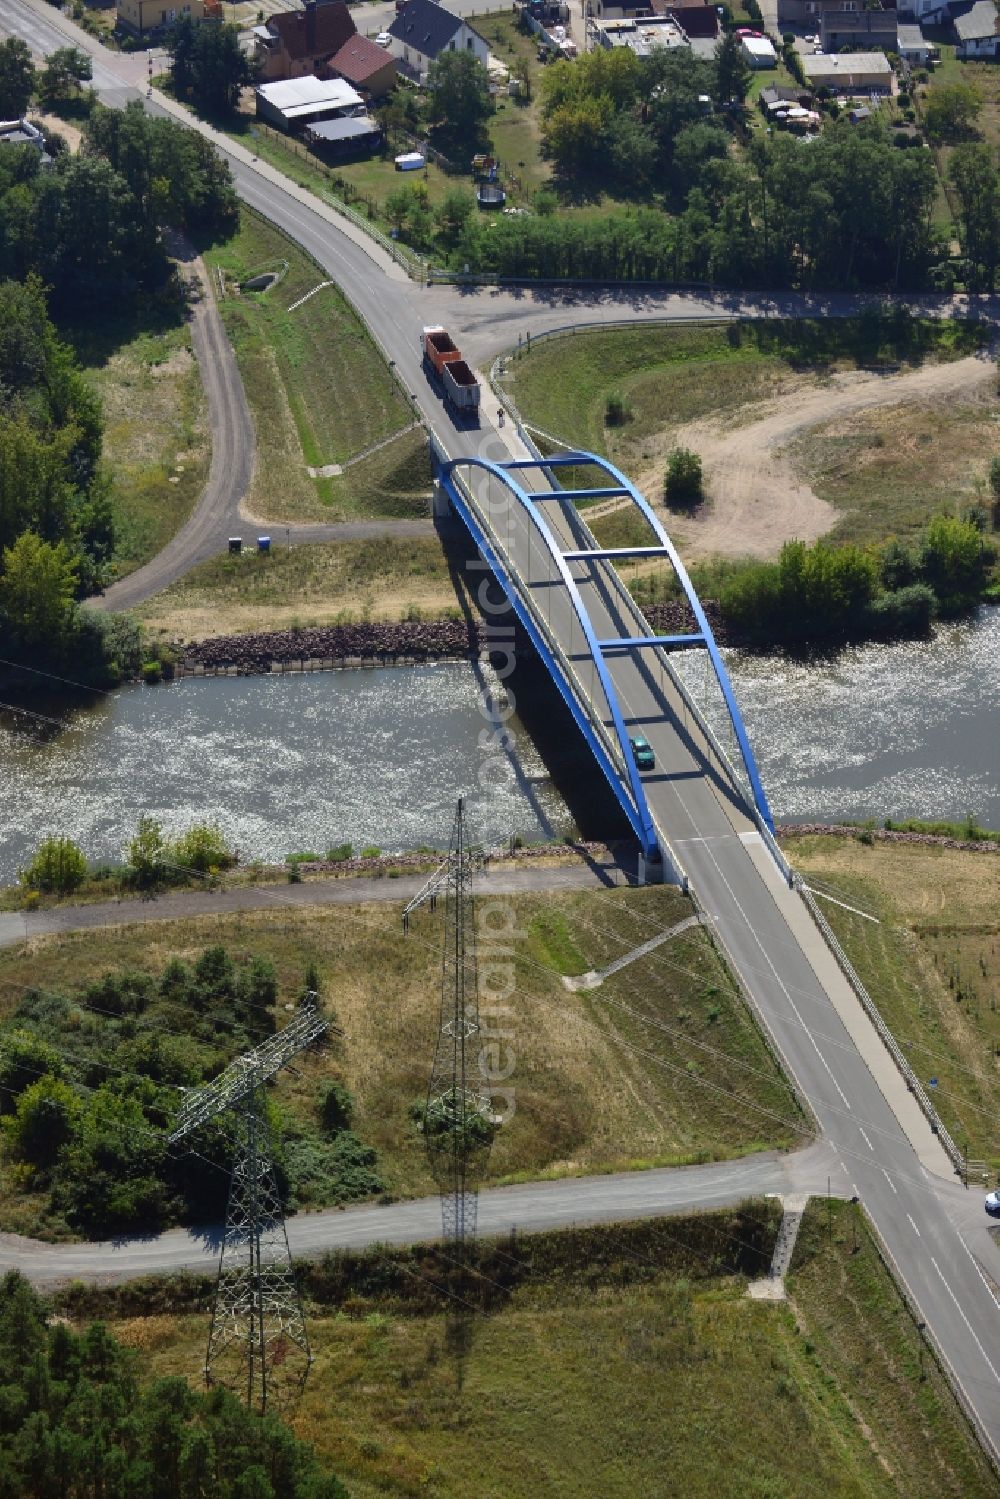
[0,609,1000,881]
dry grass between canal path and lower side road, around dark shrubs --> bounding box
[0,887,804,1220]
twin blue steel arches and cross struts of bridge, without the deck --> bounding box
[439,453,774,857]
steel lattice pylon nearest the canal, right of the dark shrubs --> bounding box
[403,799,493,1267]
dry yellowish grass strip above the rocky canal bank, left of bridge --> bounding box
[135,534,459,640]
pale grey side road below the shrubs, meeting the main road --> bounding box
[0,1144,831,1286]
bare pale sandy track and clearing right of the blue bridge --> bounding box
[639,355,997,558]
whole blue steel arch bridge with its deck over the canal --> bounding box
[435,451,774,878]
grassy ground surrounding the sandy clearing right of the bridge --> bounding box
[508,316,1000,556]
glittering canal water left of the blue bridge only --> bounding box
[0,663,573,883]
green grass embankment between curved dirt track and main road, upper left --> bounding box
[207,210,414,522]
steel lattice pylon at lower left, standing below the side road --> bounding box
[168,994,330,1415]
